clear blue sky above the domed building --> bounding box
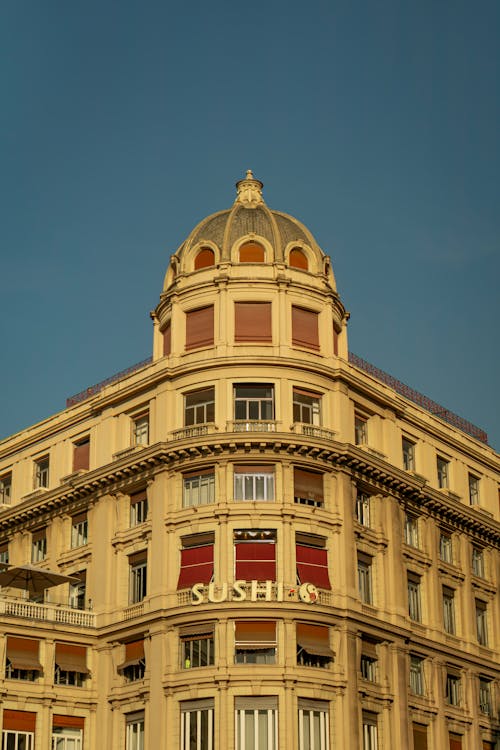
[0,0,500,449]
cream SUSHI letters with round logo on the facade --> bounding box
[191,581,318,605]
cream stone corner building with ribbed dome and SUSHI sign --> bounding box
[0,172,500,750]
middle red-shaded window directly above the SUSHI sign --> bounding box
[234,529,276,581]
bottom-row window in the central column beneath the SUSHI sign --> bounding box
[234,695,278,750]
